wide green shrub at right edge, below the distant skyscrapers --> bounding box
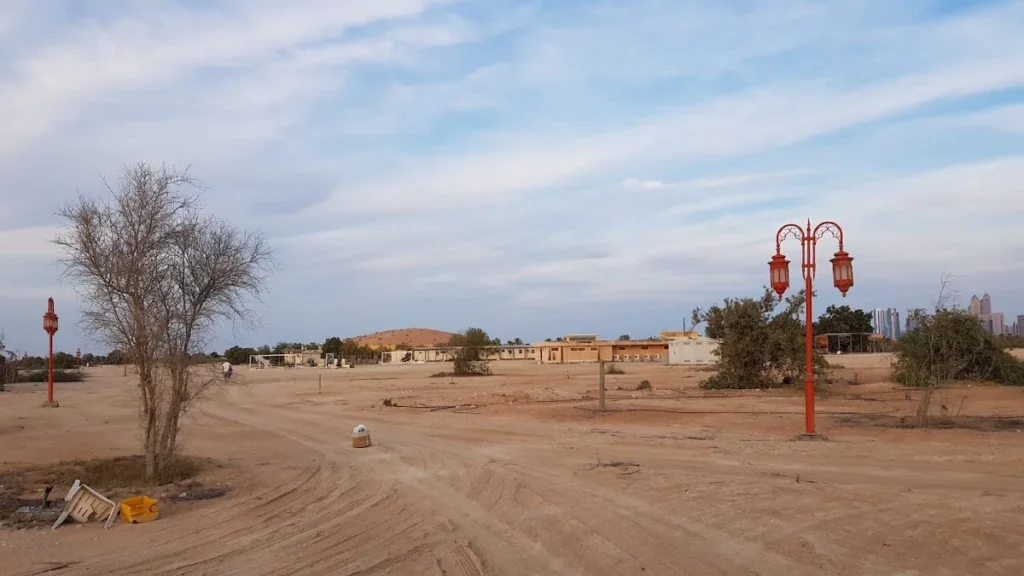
[893,310,1024,386]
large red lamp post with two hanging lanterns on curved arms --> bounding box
[768,220,853,437]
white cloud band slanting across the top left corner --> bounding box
[0,0,452,154]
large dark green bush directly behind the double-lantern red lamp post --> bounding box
[693,288,828,389]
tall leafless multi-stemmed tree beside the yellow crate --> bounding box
[54,163,273,478]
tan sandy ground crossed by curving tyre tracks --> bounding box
[0,355,1024,576]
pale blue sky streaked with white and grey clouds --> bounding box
[0,0,1024,354]
